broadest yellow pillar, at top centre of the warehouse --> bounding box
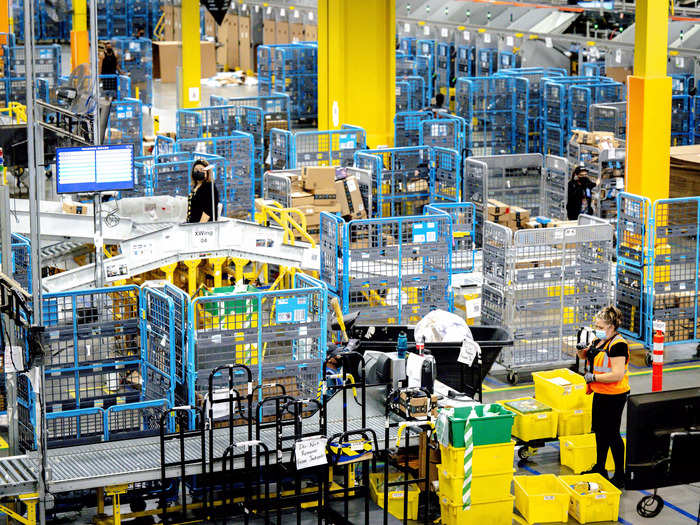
[318,0,396,147]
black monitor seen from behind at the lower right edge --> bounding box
[625,387,700,490]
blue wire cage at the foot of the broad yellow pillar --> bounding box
[270,124,367,170]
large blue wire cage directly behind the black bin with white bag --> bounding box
[320,212,453,325]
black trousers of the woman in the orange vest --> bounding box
[592,392,629,476]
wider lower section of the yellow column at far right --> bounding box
[626,76,671,202]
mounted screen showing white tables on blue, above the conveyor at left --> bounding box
[56,144,134,193]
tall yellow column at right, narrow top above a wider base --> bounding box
[626,0,671,201]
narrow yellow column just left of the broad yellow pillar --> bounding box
[181,0,202,108]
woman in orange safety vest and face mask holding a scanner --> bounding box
[578,306,630,489]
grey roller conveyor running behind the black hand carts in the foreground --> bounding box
[0,389,400,495]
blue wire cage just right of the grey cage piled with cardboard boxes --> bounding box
[355,146,462,217]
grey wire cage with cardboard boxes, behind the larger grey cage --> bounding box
[462,153,569,246]
